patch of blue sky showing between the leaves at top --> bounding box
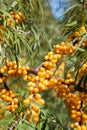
[50,0,70,19]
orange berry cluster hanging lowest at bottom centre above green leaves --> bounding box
[23,93,44,123]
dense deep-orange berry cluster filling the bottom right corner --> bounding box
[68,93,87,130]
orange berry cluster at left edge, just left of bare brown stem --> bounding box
[0,60,29,79]
